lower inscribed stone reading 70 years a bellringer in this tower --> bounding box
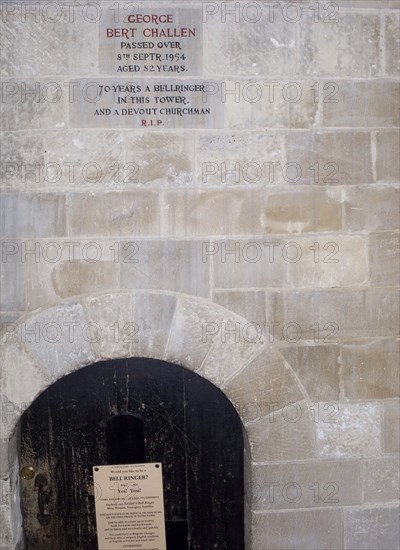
[69,78,224,129]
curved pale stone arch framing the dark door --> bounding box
[1,291,315,549]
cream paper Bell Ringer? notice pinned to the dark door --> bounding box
[93,462,167,550]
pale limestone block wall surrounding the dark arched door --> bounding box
[0,0,399,550]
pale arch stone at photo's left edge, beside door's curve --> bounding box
[0,336,50,438]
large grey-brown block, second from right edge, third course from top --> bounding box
[286,132,373,186]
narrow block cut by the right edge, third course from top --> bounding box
[376,130,400,183]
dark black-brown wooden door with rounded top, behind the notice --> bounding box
[21,358,244,550]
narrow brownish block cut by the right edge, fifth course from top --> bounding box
[369,231,400,286]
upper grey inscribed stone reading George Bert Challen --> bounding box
[99,4,203,76]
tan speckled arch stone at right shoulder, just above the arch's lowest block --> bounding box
[224,347,308,425]
